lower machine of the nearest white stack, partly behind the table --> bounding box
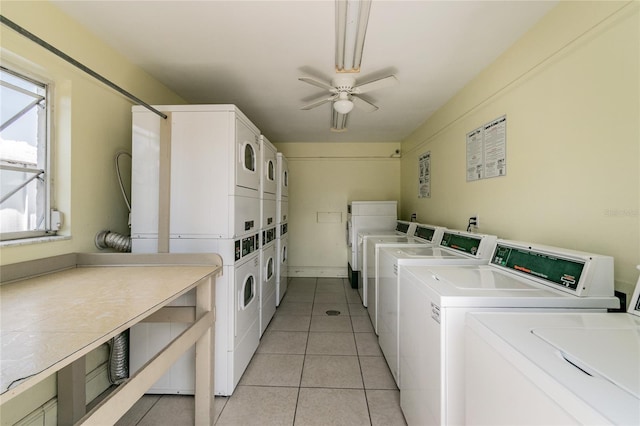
[130,234,260,395]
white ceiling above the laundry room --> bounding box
[52,0,556,143]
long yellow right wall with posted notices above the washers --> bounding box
[402,2,640,293]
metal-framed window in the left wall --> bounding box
[0,67,55,240]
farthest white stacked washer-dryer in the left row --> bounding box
[276,152,289,306]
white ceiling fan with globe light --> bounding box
[299,75,398,114]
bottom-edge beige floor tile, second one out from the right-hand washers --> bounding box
[294,388,371,426]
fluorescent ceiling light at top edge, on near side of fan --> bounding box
[336,0,371,72]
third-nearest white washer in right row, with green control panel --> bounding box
[376,229,497,386]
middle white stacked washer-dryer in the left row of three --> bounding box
[260,136,278,336]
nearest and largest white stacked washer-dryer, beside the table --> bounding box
[130,105,267,395]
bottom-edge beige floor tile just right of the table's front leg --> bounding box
[216,386,298,426]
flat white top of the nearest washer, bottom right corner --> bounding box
[466,312,640,424]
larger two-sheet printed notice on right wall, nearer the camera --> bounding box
[467,115,507,182]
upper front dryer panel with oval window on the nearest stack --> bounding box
[235,119,262,196]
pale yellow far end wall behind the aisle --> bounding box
[275,143,400,277]
